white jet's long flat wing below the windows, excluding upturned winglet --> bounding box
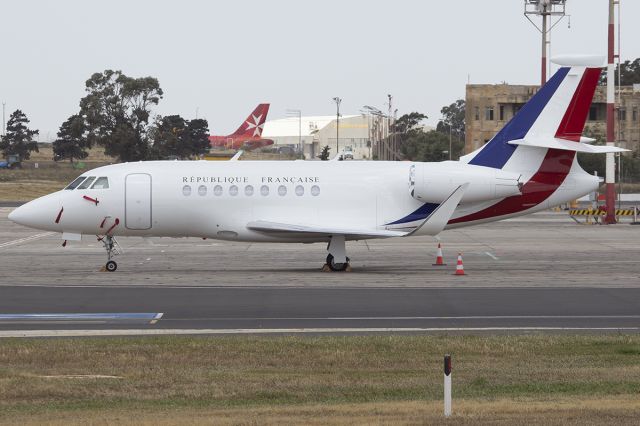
[247,220,406,239]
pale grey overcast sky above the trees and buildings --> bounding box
[0,0,640,140]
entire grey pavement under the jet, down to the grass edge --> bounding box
[0,208,640,336]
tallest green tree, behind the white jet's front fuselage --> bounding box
[80,70,163,161]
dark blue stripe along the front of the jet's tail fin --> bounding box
[469,67,570,169]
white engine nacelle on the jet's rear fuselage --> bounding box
[409,161,522,204]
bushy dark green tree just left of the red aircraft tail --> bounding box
[151,115,209,159]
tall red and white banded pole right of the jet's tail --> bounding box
[604,0,616,224]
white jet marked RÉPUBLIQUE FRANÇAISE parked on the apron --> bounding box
[9,56,622,271]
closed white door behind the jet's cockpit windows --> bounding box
[124,173,151,230]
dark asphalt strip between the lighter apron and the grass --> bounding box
[0,286,640,335]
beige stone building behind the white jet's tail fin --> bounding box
[465,84,640,153]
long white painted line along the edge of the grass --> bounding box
[0,327,640,338]
